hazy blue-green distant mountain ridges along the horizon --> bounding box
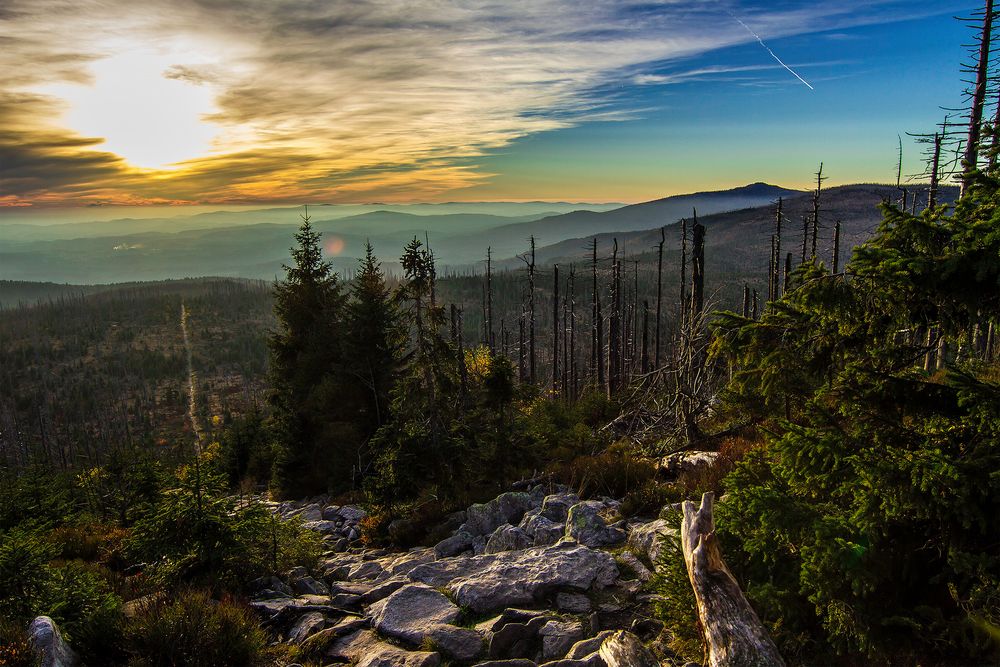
[0,183,957,284]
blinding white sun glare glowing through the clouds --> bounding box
[46,45,217,169]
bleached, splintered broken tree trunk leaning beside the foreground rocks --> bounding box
[681,492,785,667]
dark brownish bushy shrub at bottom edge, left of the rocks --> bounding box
[125,589,267,667]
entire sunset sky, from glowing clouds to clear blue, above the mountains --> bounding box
[0,0,975,209]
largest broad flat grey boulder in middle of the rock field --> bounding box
[409,545,618,614]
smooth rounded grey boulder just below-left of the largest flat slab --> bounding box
[368,584,459,645]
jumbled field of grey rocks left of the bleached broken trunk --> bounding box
[251,486,680,667]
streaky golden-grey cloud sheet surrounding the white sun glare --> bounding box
[0,0,952,203]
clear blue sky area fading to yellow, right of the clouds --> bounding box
[466,3,974,201]
